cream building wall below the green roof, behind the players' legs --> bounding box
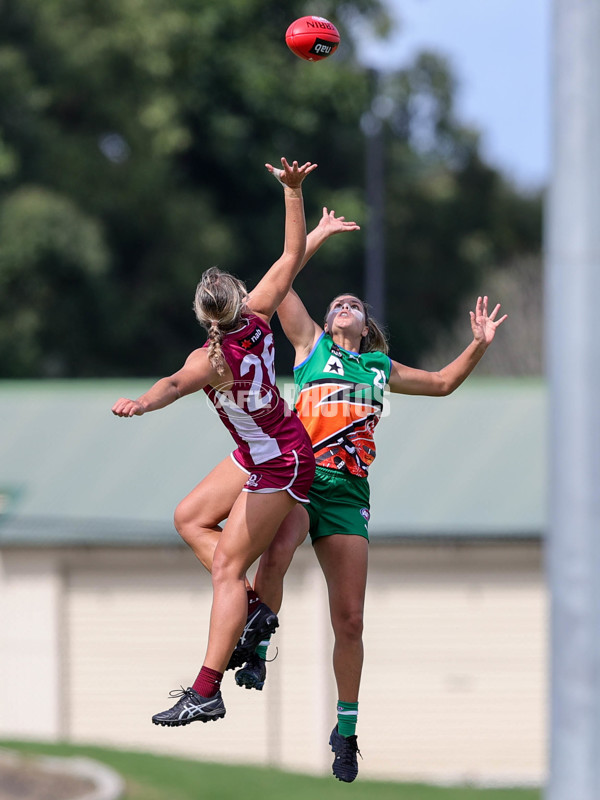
[0,543,547,784]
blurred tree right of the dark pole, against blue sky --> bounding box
[380,53,542,366]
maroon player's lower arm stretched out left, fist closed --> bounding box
[111,348,219,417]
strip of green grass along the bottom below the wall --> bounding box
[0,740,542,800]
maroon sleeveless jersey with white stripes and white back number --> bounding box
[204,314,310,470]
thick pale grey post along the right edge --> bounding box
[545,0,600,800]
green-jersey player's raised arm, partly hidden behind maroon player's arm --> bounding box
[277,207,360,363]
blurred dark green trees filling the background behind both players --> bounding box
[0,0,540,377]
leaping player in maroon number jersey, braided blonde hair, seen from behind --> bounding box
[112,158,317,726]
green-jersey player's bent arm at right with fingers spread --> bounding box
[390,297,508,397]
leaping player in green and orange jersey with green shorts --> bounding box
[236,177,507,782]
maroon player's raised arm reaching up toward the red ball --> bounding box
[246,158,317,320]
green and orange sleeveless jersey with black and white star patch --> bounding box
[294,333,391,478]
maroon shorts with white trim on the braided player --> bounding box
[231,443,315,503]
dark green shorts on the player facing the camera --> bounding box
[305,467,371,542]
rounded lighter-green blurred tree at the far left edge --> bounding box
[0,187,109,377]
